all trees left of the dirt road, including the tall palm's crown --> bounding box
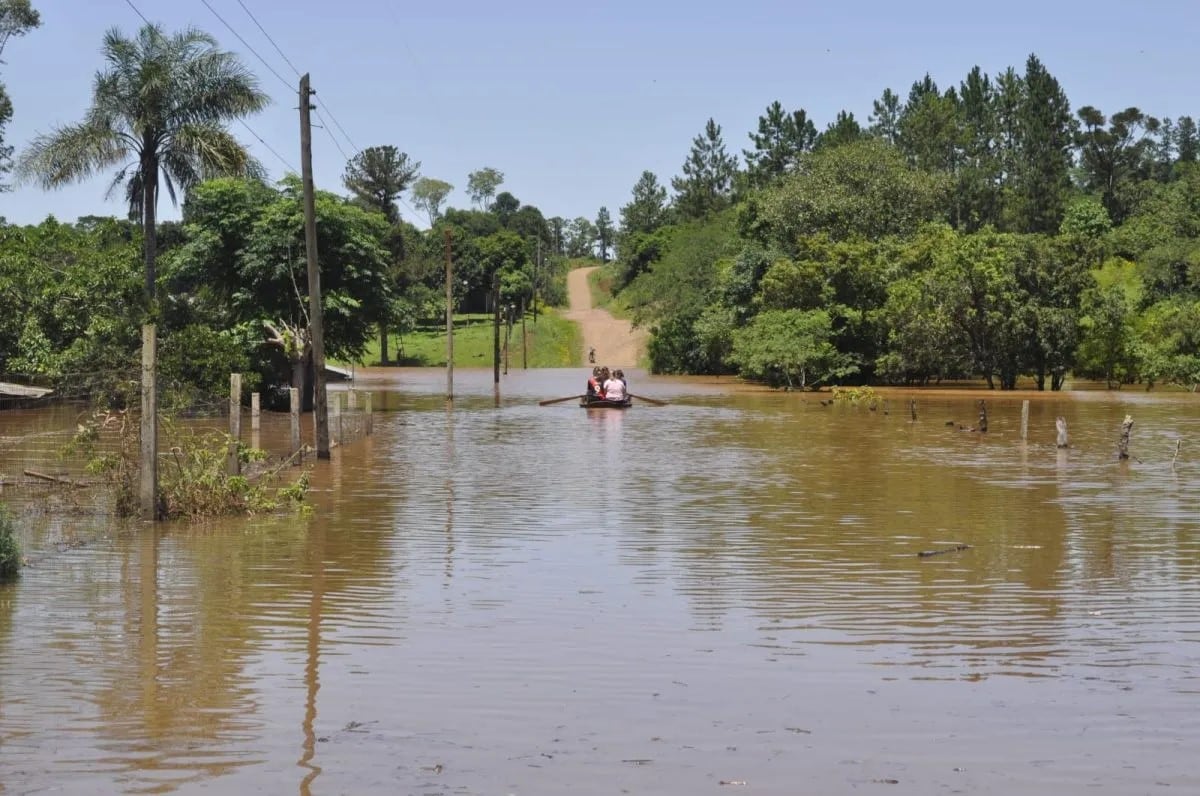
[0,14,580,407]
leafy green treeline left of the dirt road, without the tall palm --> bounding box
[0,169,565,405]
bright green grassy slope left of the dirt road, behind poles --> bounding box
[348,310,583,367]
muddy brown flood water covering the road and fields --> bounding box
[0,370,1200,796]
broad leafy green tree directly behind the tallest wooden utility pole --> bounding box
[168,176,395,400]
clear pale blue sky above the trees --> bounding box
[0,0,1200,226]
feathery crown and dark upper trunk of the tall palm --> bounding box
[17,25,269,302]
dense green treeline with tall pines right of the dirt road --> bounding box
[613,55,1200,389]
